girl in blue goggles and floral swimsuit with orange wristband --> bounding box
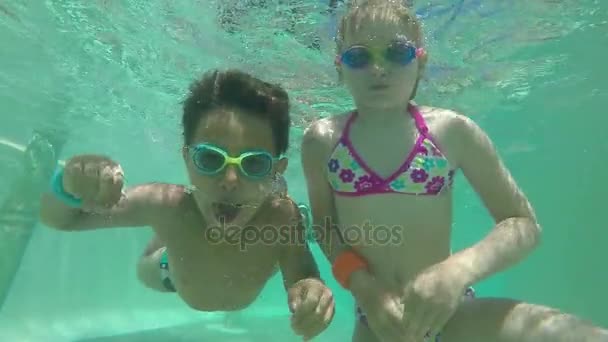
[302,0,608,342]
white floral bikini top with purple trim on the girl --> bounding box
[327,104,455,196]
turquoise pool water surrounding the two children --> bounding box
[0,0,608,342]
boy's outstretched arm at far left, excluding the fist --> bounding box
[40,183,185,231]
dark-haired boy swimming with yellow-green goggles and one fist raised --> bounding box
[41,70,334,338]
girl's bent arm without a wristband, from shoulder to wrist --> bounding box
[447,115,541,285]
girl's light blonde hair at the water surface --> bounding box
[335,0,427,99]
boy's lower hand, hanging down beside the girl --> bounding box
[288,279,335,341]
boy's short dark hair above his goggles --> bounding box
[182,69,291,154]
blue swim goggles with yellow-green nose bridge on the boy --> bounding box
[188,143,281,179]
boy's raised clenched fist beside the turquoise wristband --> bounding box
[63,155,124,208]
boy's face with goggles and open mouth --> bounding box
[183,108,287,226]
